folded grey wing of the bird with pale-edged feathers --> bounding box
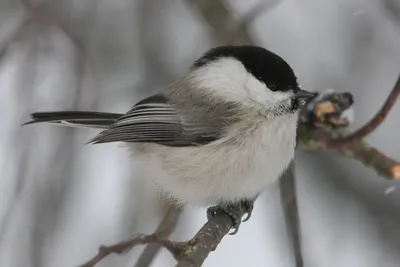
[89,94,221,146]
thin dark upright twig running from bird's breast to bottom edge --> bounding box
[279,162,304,267]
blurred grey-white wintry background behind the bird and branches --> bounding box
[0,0,400,267]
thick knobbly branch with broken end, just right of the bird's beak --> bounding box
[297,89,400,179]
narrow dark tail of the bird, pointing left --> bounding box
[23,111,123,129]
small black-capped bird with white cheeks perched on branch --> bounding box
[26,45,314,234]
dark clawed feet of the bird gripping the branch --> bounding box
[207,199,254,235]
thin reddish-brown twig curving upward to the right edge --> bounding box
[328,76,400,148]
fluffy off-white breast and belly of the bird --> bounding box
[131,114,297,206]
